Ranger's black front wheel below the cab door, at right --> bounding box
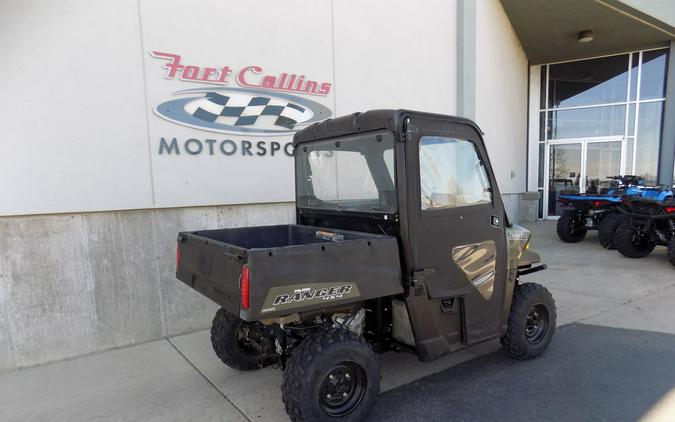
[501,283,556,360]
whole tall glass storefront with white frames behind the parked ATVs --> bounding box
[530,48,668,218]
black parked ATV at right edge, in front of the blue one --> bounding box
[614,196,675,265]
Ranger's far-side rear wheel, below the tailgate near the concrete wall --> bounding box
[211,308,262,371]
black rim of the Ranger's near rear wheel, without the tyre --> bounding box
[319,362,366,417]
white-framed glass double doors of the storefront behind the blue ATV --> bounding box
[544,137,625,217]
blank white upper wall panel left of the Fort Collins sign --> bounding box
[0,0,152,215]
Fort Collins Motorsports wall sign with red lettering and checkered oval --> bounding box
[150,51,332,156]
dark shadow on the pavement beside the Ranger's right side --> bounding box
[370,324,675,422]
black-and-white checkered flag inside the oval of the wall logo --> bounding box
[191,92,306,129]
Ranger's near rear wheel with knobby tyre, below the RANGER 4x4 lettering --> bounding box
[281,329,380,422]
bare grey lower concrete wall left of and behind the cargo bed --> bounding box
[0,204,295,372]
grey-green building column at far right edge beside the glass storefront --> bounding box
[658,41,675,186]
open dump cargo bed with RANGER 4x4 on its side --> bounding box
[176,224,403,321]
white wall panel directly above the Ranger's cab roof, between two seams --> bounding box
[333,0,458,116]
